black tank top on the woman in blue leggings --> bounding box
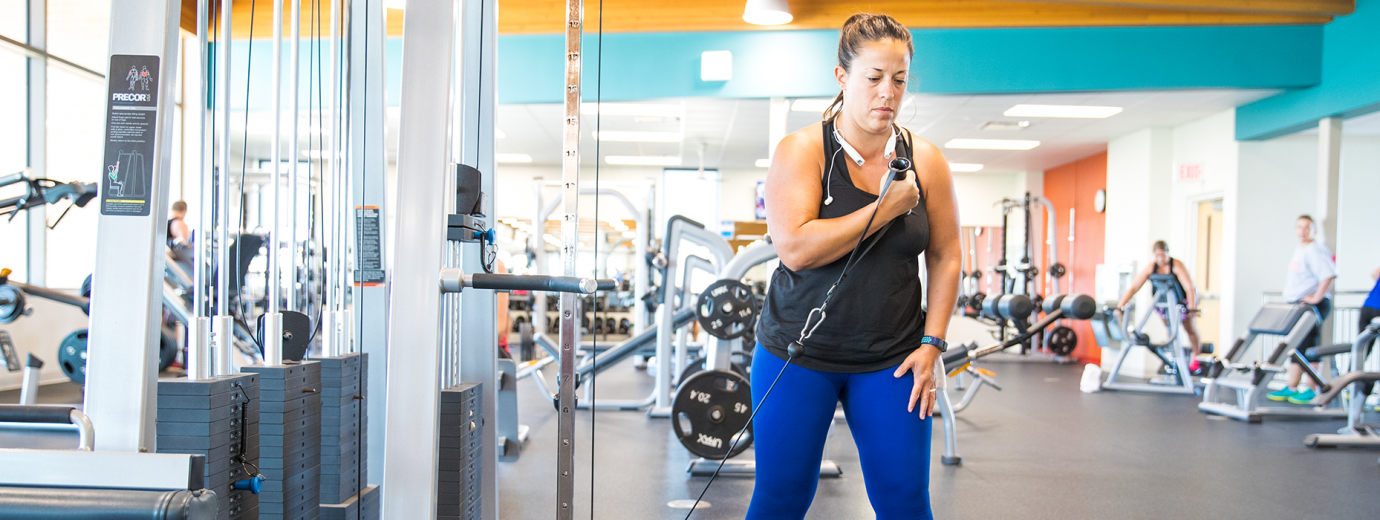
[756,123,930,374]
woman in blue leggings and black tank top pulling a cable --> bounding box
[747,14,959,520]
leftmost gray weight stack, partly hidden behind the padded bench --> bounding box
[155,374,259,520]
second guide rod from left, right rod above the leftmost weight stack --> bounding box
[211,1,233,375]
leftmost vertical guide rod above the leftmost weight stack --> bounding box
[186,0,215,381]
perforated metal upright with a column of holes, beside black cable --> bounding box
[557,0,584,520]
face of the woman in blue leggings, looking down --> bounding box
[834,39,911,132]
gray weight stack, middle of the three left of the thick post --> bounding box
[240,361,322,520]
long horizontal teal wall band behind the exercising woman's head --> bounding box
[230,25,1324,110]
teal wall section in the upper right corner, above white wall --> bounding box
[1236,0,1380,141]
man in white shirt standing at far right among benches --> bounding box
[1267,215,1337,404]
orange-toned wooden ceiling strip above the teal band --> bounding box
[182,0,1355,39]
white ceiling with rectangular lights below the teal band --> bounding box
[495,90,1275,172]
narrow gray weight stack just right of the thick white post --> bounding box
[436,383,484,520]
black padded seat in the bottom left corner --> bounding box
[0,487,217,520]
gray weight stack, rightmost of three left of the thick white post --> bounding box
[316,353,364,520]
